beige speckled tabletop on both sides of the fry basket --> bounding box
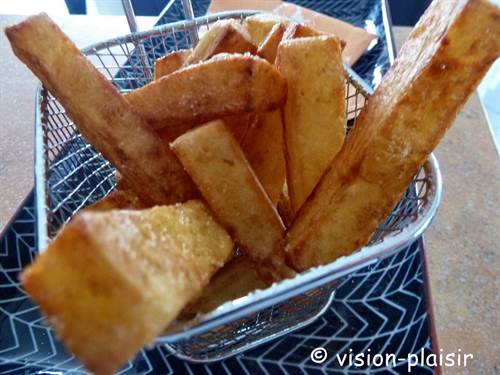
[0,15,500,373]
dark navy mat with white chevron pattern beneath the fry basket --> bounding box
[0,0,433,374]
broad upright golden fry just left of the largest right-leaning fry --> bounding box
[276,36,346,213]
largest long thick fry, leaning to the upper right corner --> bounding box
[288,0,500,270]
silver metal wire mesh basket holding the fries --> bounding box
[35,11,441,362]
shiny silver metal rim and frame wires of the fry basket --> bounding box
[35,11,442,362]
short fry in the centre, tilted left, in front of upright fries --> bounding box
[171,121,284,261]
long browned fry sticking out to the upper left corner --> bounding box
[5,14,196,205]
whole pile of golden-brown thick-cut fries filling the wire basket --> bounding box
[6,0,500,374]
